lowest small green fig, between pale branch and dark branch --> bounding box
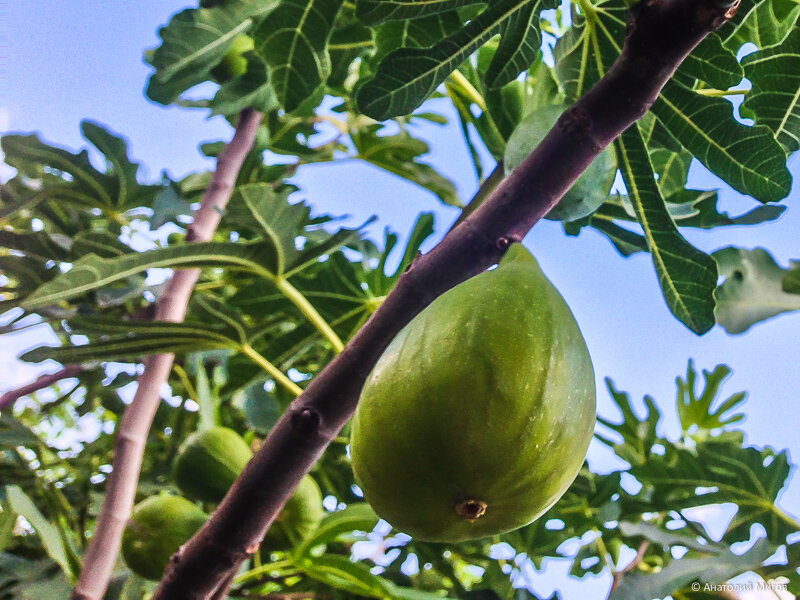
[122,494,208,581]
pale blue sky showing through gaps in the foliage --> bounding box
[0,0,800,591]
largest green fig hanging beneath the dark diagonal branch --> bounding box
[350,244,595,542]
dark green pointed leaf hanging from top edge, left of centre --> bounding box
[252,0,343,112]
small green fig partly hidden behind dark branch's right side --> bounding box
[261,475,325,552]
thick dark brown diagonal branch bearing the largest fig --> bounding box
[153,0,738,600]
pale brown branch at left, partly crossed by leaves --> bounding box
[72,110,261,600]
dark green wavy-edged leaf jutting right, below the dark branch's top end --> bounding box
[652,80,792,202]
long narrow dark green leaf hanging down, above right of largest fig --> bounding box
[615,126,717,334]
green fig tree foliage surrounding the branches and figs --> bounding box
[0,0,800,600]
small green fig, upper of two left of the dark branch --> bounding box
[172,427,253,502]
